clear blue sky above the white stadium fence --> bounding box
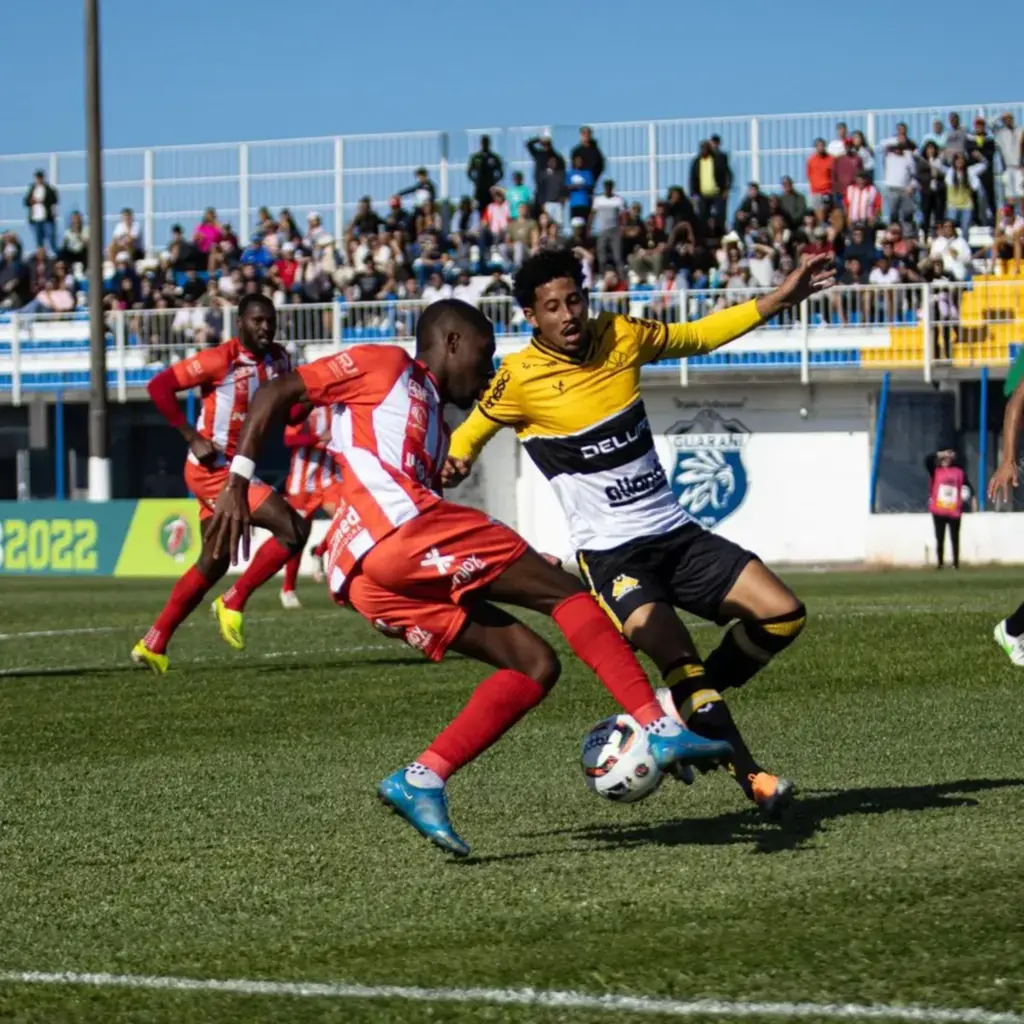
[6,0,1024,154]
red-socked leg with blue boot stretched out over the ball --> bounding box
[486,548,731,767]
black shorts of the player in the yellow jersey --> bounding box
[577,522,757,629]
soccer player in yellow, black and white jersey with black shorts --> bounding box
[444,250,835,816]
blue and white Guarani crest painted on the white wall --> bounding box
[666,409,751,528]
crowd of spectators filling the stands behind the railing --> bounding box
[0,114,1024,341]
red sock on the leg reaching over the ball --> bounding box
[551,594,665,725]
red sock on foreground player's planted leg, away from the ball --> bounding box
[416,669,547,778]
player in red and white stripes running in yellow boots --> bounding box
[131,294,309,674]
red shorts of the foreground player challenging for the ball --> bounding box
[335,502,528,662]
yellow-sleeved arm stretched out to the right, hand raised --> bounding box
[659,253,836,361]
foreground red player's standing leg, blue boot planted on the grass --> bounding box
[379,602,560,856]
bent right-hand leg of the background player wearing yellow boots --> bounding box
[213,480,309,650]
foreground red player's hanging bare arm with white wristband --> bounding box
[209,371,306,565]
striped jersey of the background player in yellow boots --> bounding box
[171,338,292,465]
